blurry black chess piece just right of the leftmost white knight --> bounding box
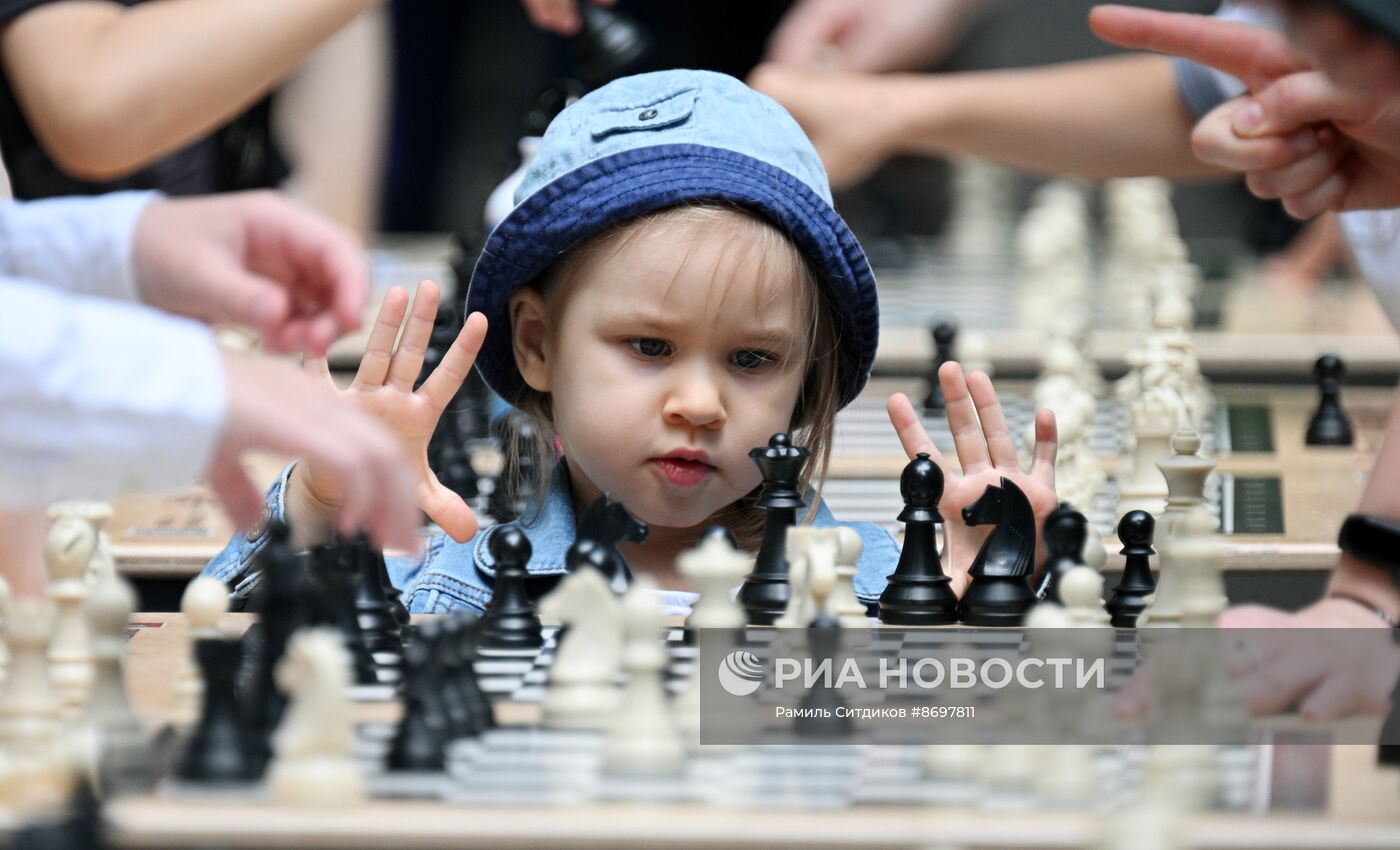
[385,620,448,772]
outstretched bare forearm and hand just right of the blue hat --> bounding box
[750,55,1224,186]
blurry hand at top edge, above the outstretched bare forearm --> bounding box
[767,0,990,73]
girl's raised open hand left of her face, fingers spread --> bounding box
[295,280,486,543]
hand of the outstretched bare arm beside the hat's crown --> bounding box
[748,63,902,189]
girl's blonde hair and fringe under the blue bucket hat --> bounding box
[503,202,840,550]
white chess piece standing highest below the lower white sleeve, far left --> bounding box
[43,517,97,711]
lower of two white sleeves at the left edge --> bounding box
[0,277,227,507]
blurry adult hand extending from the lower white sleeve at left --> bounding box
[207,351,419,550]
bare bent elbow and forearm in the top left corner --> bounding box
[0,0,381,179]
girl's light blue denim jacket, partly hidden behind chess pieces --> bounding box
[203,465,899,613]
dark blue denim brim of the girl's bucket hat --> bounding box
[466,144,879,406]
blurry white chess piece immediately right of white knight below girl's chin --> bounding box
[603,576,685,776]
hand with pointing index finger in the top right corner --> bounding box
[1091,7,1400,217]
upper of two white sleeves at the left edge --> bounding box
[0,192,158,301]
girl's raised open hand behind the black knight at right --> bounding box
[889,363,1057,597]
